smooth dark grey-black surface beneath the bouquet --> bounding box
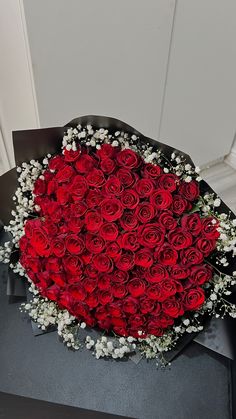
[0,258,232,419]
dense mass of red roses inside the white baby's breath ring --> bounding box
[20,144,219,337]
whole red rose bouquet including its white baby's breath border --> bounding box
[1,117,236,366]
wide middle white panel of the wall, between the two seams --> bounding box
[24,0,175,137]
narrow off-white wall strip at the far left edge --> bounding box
[0,0,39,173]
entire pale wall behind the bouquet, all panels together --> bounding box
[0,0,236,170]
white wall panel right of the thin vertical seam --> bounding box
[160,0,236,164]
